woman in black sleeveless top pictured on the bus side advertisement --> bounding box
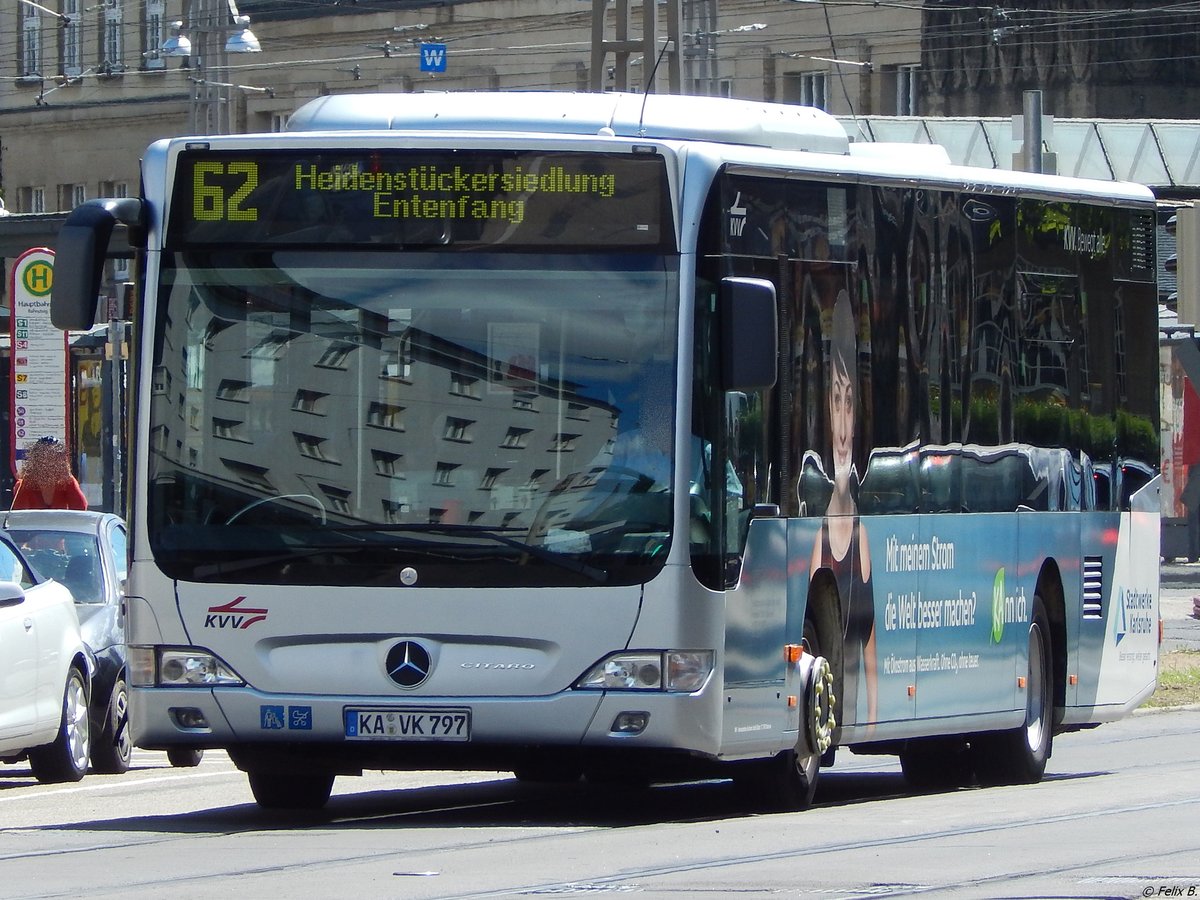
[811,294,878,725]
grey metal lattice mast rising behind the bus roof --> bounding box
[590,0,683,94]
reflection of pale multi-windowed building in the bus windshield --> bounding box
[151,295,635,528]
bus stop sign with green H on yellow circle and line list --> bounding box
[8,248,71,478]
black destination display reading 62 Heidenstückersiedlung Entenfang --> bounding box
[167,150,673,248]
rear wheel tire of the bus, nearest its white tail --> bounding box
[971,596,1054,785]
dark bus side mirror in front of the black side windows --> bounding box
[718,277,779,391]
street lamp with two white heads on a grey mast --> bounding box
[161,0,263,134]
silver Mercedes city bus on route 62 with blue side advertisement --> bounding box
[53,92,1159,808]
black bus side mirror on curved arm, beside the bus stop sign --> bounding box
[50,197,143,331]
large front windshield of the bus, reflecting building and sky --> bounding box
[148,248,678,586]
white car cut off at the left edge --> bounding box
[0,534,94,782]
